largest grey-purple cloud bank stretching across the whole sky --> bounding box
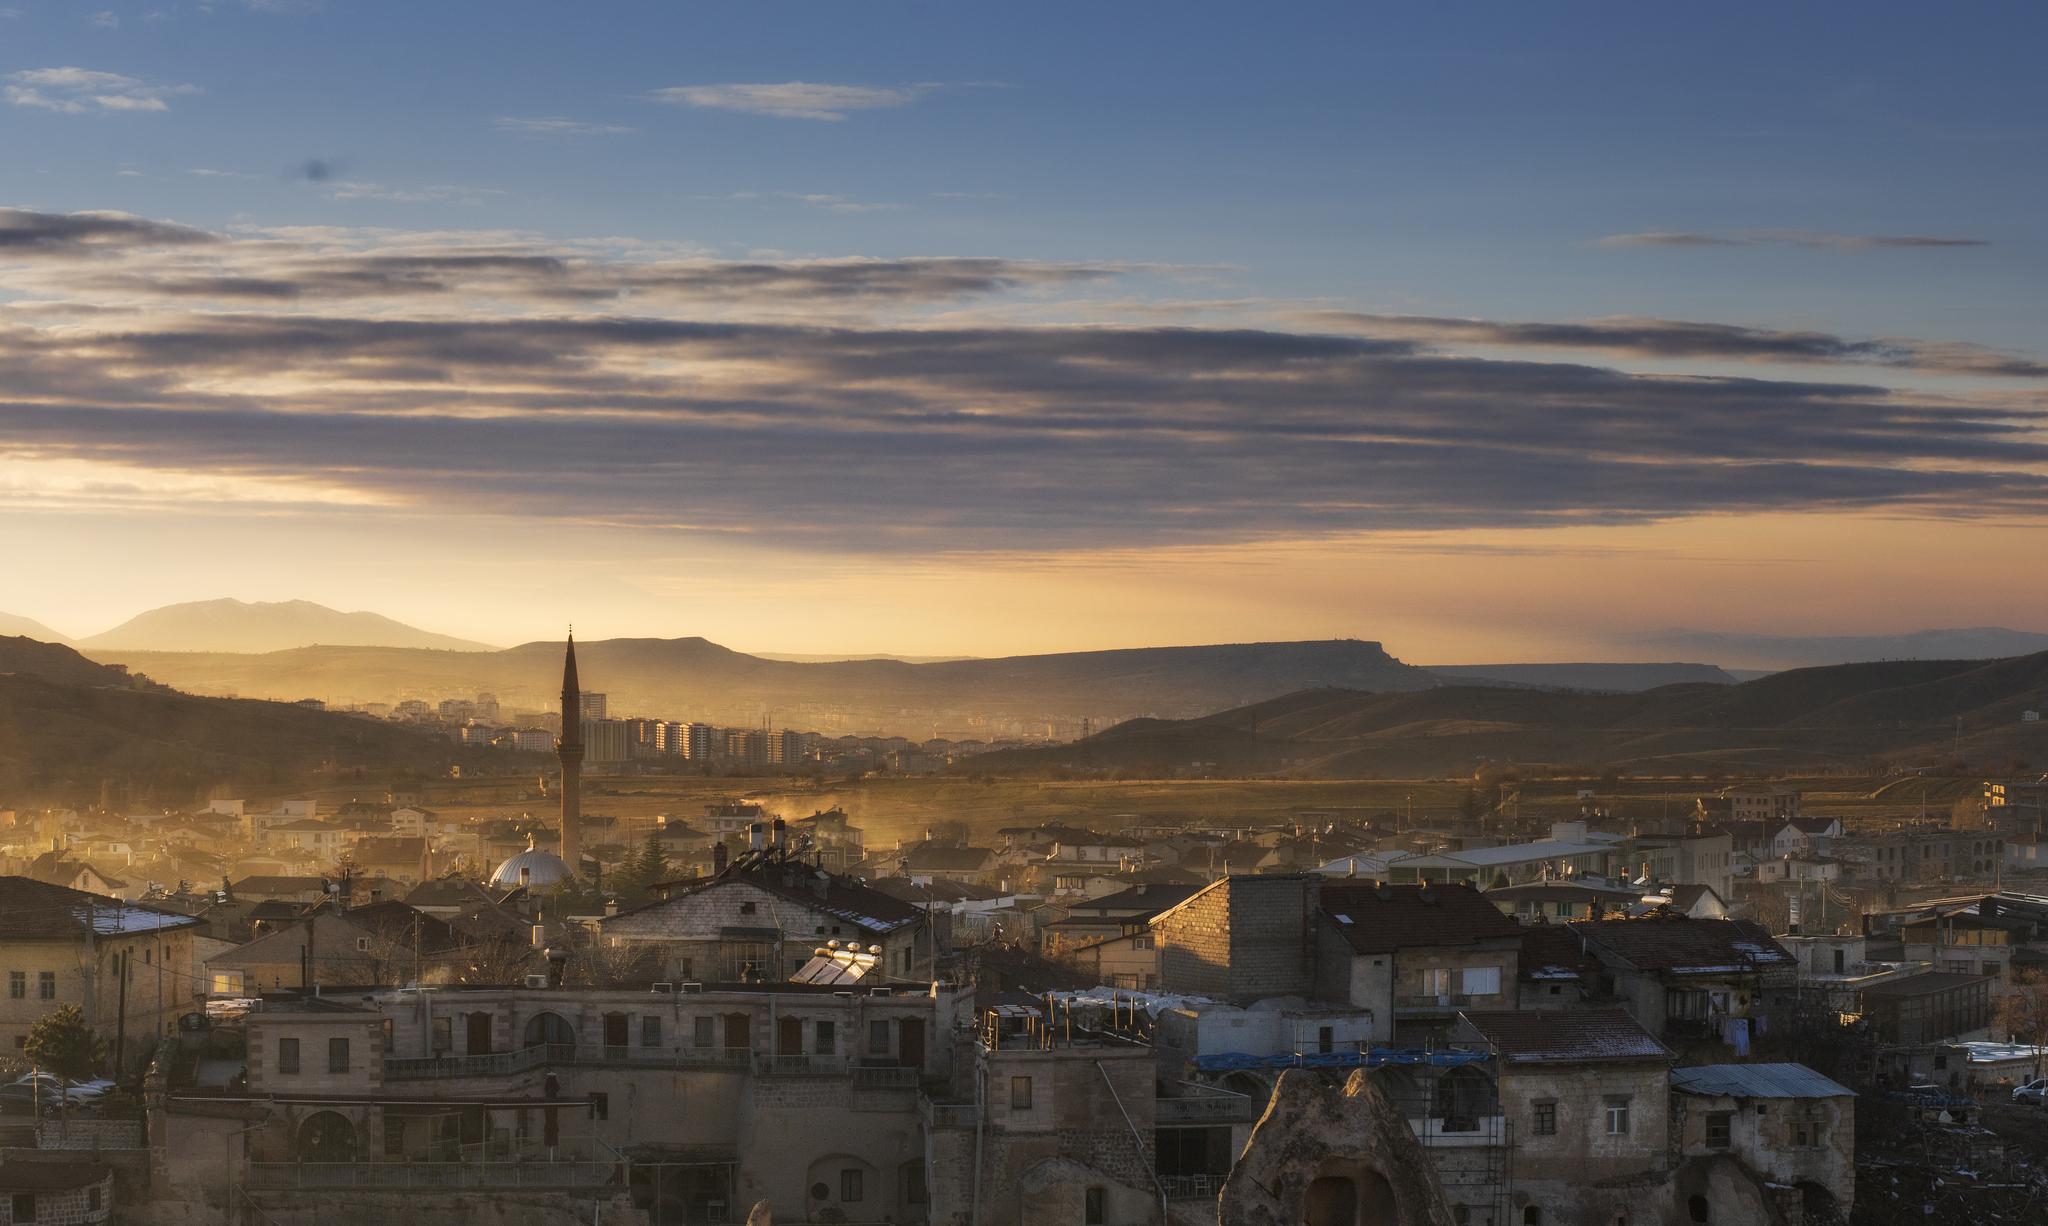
[0,211,2048,551]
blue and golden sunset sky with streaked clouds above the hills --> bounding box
[0,0,2048,663]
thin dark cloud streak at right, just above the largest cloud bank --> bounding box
[1288,311,2048,379]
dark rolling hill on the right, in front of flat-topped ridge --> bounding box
[975,651,2048,778]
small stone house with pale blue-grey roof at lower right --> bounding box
[1671,1064,1855,1222]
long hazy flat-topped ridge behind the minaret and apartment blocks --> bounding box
[86,639,1438,731]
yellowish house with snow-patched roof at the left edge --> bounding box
[0,876,203,1072]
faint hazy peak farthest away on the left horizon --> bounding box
[78,600,498,653]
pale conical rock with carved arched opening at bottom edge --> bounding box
[1219,1068,1452,1226]
